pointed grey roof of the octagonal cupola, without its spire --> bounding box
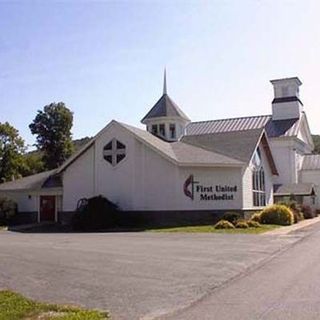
[141,93,190,124]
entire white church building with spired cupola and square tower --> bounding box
[0,77,320,222]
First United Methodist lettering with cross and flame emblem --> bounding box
[183,174,238,201]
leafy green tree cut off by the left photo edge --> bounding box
[0,122,25,182]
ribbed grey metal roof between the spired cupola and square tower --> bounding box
[187,115,300,137]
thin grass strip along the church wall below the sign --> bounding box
[149,224,280,234]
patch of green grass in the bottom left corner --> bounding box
[0,291,111,320]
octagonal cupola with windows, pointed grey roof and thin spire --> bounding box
[141,70,190,142]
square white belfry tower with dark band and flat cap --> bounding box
[270,77,303,120]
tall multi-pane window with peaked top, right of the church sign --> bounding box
[252,148,266,207]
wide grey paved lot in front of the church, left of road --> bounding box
[0,231,299,320]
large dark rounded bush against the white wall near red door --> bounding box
[71,196,119,231]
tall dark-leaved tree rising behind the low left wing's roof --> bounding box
[29,102,73,169]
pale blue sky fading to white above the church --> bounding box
[0,0,320,146]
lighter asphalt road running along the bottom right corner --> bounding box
[162,224,320,320]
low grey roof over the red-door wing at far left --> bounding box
[0,169,61,192]
